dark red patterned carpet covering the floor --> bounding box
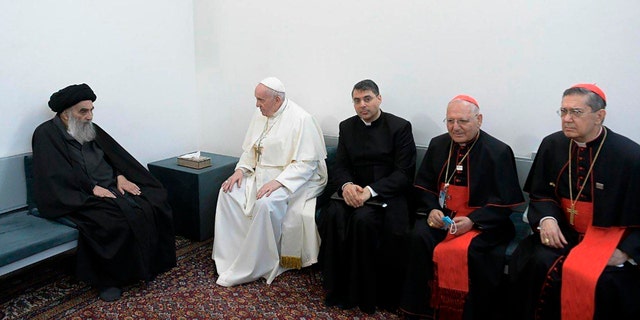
[0,238,398,319]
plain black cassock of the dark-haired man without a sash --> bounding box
[319,112,416,311]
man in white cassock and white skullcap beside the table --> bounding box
[212,77,327,287]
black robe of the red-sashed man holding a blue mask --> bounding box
[401,131,524,319]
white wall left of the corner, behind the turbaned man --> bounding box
[0,0,200,164]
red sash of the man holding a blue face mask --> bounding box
[432,185,480,319]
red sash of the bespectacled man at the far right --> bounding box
[560,199,625,320]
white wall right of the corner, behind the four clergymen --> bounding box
[194,0,640,155]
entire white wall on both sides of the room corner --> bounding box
[0,0,640,163]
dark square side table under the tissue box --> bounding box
[147,152,238,241]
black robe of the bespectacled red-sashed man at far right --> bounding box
[509,128,640,319]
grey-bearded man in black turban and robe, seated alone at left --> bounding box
[32,83,176,301]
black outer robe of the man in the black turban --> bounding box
[32,119,176,287]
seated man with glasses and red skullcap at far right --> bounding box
[509,84,640,319]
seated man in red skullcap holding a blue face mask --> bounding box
[400,95,524,319]
